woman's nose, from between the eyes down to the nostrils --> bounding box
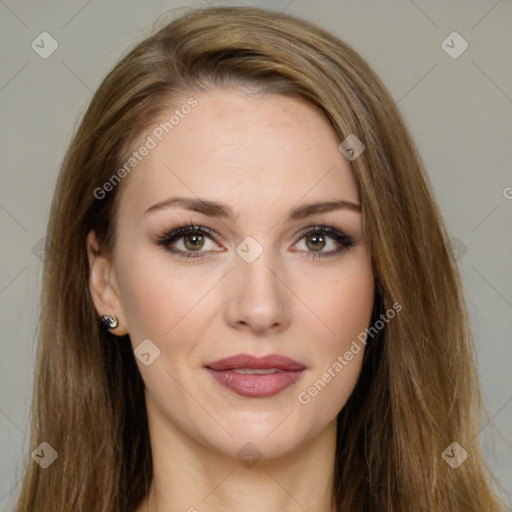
[225,250,293,334]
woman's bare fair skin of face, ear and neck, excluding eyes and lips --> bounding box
[87,89,374,512]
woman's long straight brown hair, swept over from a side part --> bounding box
[17,7,501,512]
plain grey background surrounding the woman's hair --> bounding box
[0,0,512,510]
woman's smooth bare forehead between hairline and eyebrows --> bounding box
[119,89,359,222]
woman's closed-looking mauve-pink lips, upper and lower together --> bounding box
[205,354,306,398]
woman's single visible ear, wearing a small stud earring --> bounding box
[87,231,128,336]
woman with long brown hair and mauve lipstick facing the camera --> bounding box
[17,7,502,512]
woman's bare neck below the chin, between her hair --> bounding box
[138,394,336,512]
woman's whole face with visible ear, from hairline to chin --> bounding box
[89,89,374,457]
